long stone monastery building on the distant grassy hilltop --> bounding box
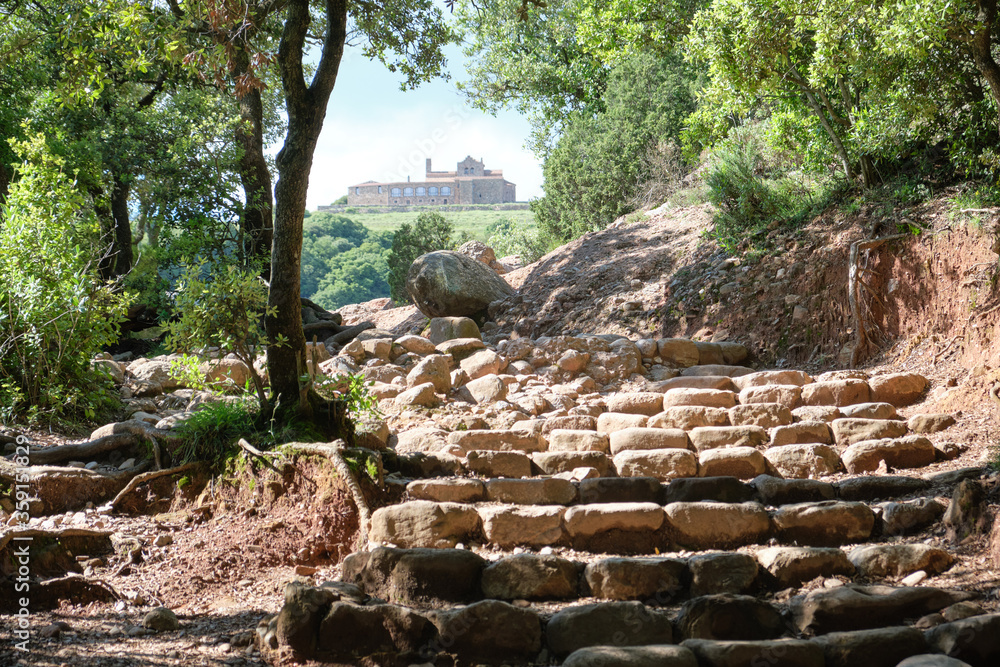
[347,157,515,206]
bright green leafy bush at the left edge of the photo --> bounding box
[0,136,129,422]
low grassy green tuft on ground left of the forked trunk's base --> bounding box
[176,398,262,466]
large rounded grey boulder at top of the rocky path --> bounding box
[406,250,514,317]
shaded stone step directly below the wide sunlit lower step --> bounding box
[343,544,953,606]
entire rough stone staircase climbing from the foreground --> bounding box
[258,330,1000,667]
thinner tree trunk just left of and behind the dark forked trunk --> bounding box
[233,46,274,277]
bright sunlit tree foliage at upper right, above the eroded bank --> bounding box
[686,0,996,187]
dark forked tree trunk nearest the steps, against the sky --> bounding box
[264,0,347,418]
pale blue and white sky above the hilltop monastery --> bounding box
[306,41,542,210]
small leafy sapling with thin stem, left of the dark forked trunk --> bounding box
[165,259,267,405]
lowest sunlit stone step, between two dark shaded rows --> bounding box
[369,486,944,554]
